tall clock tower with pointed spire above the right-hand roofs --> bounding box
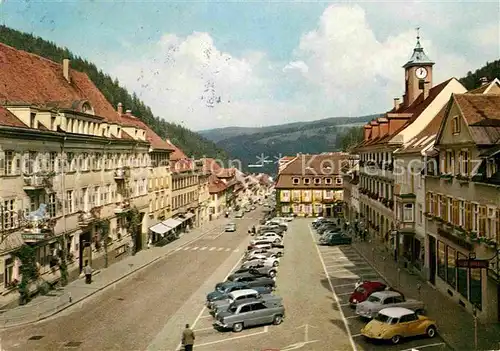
[403,29,434,106]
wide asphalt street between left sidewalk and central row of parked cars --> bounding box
[0,213,260,351]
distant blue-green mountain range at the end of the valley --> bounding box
[199,114,380,174]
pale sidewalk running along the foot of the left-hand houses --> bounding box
[0,217,227,328]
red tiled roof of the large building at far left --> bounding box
[0,43,118,122]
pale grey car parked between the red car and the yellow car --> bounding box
[356,290,425,319]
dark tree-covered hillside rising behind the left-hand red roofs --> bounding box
[0,25,227,159]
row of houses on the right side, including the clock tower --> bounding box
[344,34,500,322]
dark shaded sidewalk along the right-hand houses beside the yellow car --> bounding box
[352,242,500,351]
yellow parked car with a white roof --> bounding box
[361,307,437,344]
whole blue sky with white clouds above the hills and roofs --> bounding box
[0,0,500,130]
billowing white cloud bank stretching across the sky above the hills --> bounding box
[112,3,498,130]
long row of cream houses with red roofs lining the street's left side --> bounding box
[0,44,274,301]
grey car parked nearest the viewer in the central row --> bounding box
[214,300,285,333]
